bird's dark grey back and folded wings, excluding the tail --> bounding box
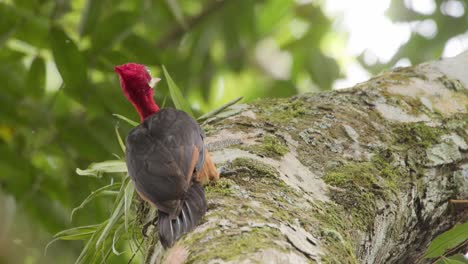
[126,109,203,213]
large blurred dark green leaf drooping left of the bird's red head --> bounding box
[50,26,88,98]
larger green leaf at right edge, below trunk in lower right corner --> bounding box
[424,222,468,258]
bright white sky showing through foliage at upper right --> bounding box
[324,0,468,89]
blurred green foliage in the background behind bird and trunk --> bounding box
[0,0,467,263]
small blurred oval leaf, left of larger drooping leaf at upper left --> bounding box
[26,56,46,98]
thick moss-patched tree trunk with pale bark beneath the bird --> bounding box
[147,52,468,263]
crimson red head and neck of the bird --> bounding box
[114,63,159,121]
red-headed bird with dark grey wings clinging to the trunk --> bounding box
[114,63,219,248]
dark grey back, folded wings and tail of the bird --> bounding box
[126,108,206,248]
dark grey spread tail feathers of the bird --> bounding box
[158,183,207,248]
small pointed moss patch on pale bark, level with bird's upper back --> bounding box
[241,135,289,159]
